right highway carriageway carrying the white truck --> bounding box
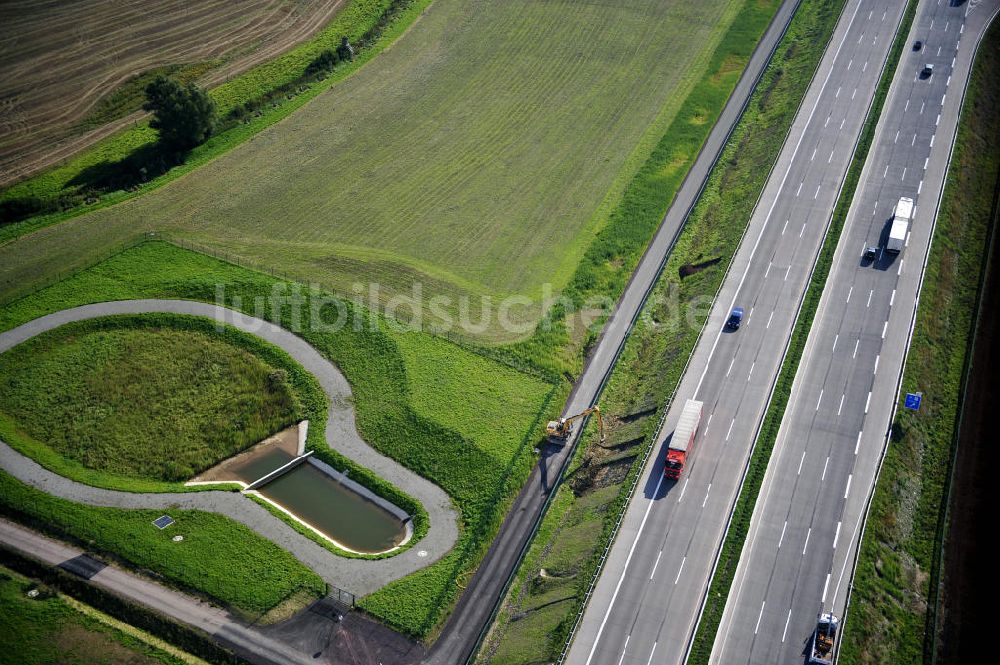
[711,0,1000,664]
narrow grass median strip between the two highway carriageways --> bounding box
[689,0,917,664]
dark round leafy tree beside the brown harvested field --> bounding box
[142,76,215,151]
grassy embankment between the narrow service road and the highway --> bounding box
[480,0,843,664]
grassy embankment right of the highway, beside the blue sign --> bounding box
[840,23,1000,664]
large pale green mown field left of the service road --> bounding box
[0,0,744,338]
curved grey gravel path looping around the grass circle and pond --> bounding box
[0,300,458,596]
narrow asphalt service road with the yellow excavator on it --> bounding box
[425,0,798,665]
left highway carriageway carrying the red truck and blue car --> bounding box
[566,0,905,665]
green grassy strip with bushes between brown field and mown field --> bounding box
[0,0,431,236]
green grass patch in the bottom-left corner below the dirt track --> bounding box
[0,568,191,665]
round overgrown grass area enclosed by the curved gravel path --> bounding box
[0,316,301,481]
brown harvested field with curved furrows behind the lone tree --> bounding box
[0,0,344,183]
